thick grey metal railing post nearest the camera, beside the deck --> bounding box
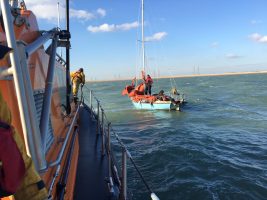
[121,147,127,200]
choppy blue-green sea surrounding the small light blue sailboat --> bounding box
[82,74,267,200]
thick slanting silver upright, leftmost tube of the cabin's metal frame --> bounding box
[0,0,46,170]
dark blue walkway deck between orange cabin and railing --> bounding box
[74,105,111,200]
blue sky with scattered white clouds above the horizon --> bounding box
[25,0,267,80]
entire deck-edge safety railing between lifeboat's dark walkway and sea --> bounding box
[81,85,159,200]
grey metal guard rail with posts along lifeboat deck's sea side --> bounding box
[81,86,159,200]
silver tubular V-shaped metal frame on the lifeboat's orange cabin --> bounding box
[0,0,75,172]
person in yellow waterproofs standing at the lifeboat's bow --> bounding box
[70,68,85,100]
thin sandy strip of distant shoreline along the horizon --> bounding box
[86,71,267,83]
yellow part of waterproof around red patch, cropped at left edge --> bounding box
[0,91,47,200]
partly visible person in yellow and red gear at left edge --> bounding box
[0,91,48,200]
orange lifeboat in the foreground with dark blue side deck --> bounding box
[0,0,161,200]
